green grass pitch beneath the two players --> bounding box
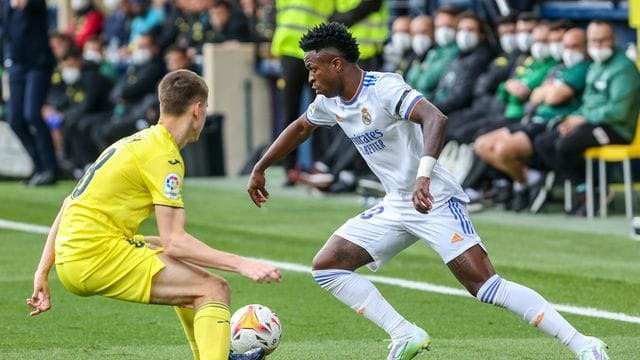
[0,178,640,360]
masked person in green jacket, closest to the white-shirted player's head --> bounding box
[409,6,460,98]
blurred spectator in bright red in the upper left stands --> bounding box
[67,0,104,49]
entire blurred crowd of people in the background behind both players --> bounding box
[2,0,640,214]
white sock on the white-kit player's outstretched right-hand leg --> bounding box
[477,274,589,354]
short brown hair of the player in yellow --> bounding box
[158,70,209,115]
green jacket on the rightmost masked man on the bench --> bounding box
[575,50,640,141]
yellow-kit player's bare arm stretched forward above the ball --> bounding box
[155,205,282,283]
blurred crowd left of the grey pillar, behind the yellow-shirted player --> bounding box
[1,0,258,186]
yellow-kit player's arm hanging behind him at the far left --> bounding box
[27,199,67,316]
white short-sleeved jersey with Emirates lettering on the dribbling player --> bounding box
[306,72,469,202]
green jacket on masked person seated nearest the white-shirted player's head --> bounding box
[409,43,460,99]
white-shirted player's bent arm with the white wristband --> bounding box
[409,100,447,214]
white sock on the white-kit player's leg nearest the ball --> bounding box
[311,269,416,339]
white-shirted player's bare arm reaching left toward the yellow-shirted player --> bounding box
[247,114,315,207]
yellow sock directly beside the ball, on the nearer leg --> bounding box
[193,301,231,360]
